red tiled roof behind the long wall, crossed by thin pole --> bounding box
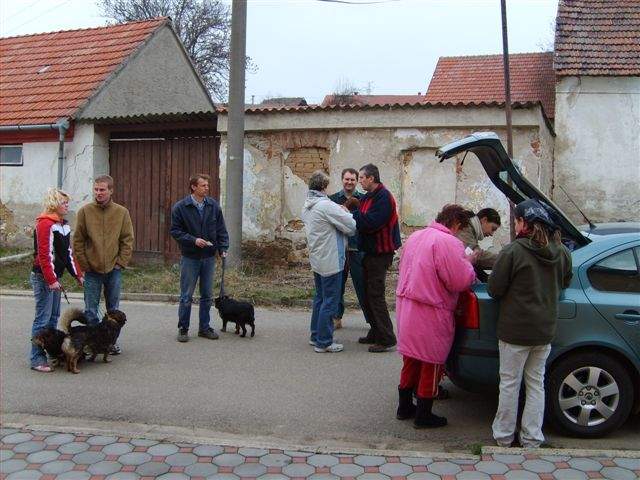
[425,52,555,118]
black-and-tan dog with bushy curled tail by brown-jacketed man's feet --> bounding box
[60,308,127,373]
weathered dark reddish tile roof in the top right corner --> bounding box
[554,0,640,76]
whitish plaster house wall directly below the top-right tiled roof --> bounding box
[554,77,640,224]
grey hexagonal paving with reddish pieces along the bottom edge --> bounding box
[0,428,640,480]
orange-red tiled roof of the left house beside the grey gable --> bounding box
[0,18,169,125]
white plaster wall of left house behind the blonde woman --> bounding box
[0,124,109,245]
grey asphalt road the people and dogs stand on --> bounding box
[0,296,640,452]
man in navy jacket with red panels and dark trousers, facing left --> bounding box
[346,164,401,353]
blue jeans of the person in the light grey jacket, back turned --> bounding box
[311,271,343,348]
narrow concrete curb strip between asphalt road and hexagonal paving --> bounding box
[1,413,479,460]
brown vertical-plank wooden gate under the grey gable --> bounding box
[109,134,220,260]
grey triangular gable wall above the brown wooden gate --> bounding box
[78,26,213,118]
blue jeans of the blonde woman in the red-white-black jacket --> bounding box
[29,272,61,367]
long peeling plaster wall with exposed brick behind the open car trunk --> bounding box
[220,105,553,258]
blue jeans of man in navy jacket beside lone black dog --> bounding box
[178,257,216,332]
